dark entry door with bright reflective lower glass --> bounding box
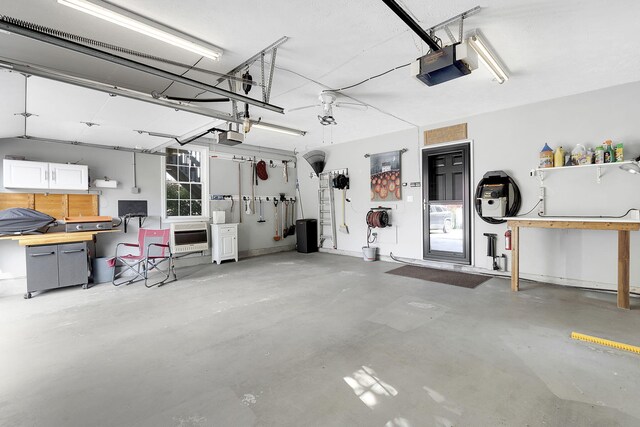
[422,143,471,264]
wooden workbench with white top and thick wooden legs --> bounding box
[505,218,640,309]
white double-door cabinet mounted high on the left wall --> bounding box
[2,159,89,190]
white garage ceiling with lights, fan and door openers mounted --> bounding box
[0,0,640,150]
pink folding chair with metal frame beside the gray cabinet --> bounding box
[111,228,178,288]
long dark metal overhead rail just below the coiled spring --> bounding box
[0,20,284,114]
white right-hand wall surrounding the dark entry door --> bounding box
[299,83,640,289]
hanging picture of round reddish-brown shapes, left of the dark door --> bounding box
[370,150,402,201]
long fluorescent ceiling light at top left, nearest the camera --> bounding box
[58,0,222,60]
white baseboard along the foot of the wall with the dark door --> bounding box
[319,248,640,293]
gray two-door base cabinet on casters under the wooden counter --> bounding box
[24,242,89,299]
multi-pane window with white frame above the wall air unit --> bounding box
[163,147,208,219]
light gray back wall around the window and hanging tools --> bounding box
[0,139,296,279]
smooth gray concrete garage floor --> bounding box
[0,252,640,427]
